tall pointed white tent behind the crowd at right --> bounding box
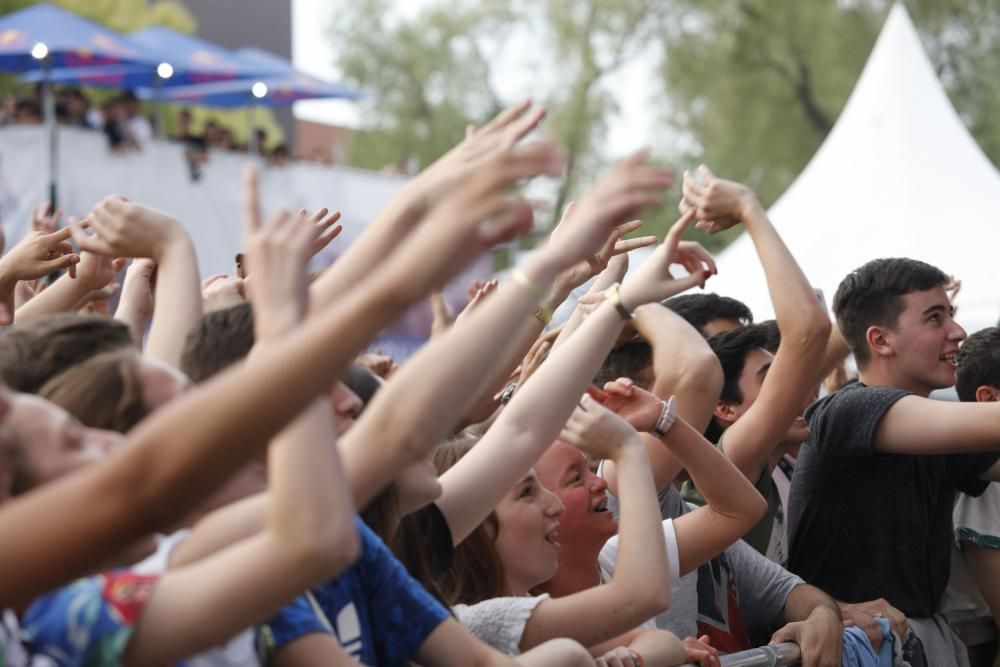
[707,4,1000,333]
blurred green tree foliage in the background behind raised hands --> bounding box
[333,0,1000,249]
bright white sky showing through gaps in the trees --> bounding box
[292,0,657,158]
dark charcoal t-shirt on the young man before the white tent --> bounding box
[788,383,1000,617]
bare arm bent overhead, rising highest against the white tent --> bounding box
[684,167,830,482]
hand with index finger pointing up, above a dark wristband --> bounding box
[621,209,714,310]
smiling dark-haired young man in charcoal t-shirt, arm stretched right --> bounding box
[788,259,1000,665]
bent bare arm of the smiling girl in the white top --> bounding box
[521,400,671,650]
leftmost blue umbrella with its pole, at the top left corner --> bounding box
[0,4,158,206]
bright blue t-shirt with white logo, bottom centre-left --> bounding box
[265,518,449,667]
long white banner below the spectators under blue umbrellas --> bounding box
[0,126,492,336]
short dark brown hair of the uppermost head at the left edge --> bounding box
[0,313,135,394]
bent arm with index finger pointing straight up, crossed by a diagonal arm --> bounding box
[125,205,360,665]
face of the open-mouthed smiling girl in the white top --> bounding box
[494,470,565,595]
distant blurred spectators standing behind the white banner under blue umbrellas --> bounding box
[0,86,290,166]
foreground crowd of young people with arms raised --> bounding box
[0,101,1000,667]
